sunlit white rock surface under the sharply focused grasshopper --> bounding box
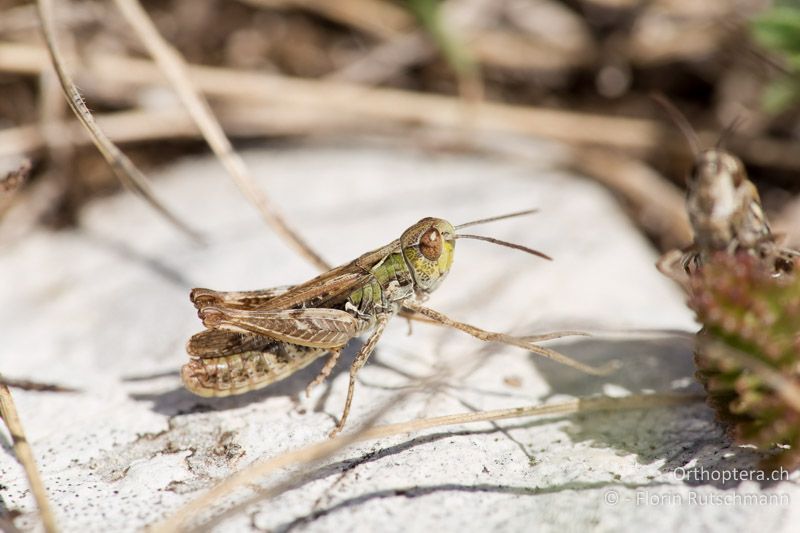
[0,143,800,532]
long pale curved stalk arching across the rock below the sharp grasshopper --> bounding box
[150,394,704,533]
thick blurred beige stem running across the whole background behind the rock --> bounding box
[0,42,800,169]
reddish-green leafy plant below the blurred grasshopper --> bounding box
[690,253,800,469]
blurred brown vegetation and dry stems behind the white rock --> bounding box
[0,0,800,249]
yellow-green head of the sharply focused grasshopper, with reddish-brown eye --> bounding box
[400,218,456,292]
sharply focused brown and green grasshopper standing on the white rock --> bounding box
[181,211,608,436]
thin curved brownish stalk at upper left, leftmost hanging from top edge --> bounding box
[37,0,202,242]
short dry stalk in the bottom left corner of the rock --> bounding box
[0,377,58,533]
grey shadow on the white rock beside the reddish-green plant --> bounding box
[532,334,774,489]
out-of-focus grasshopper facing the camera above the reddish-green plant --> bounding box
[656,97,798,288]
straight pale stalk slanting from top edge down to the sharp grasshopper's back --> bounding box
[115,0,331,271]
